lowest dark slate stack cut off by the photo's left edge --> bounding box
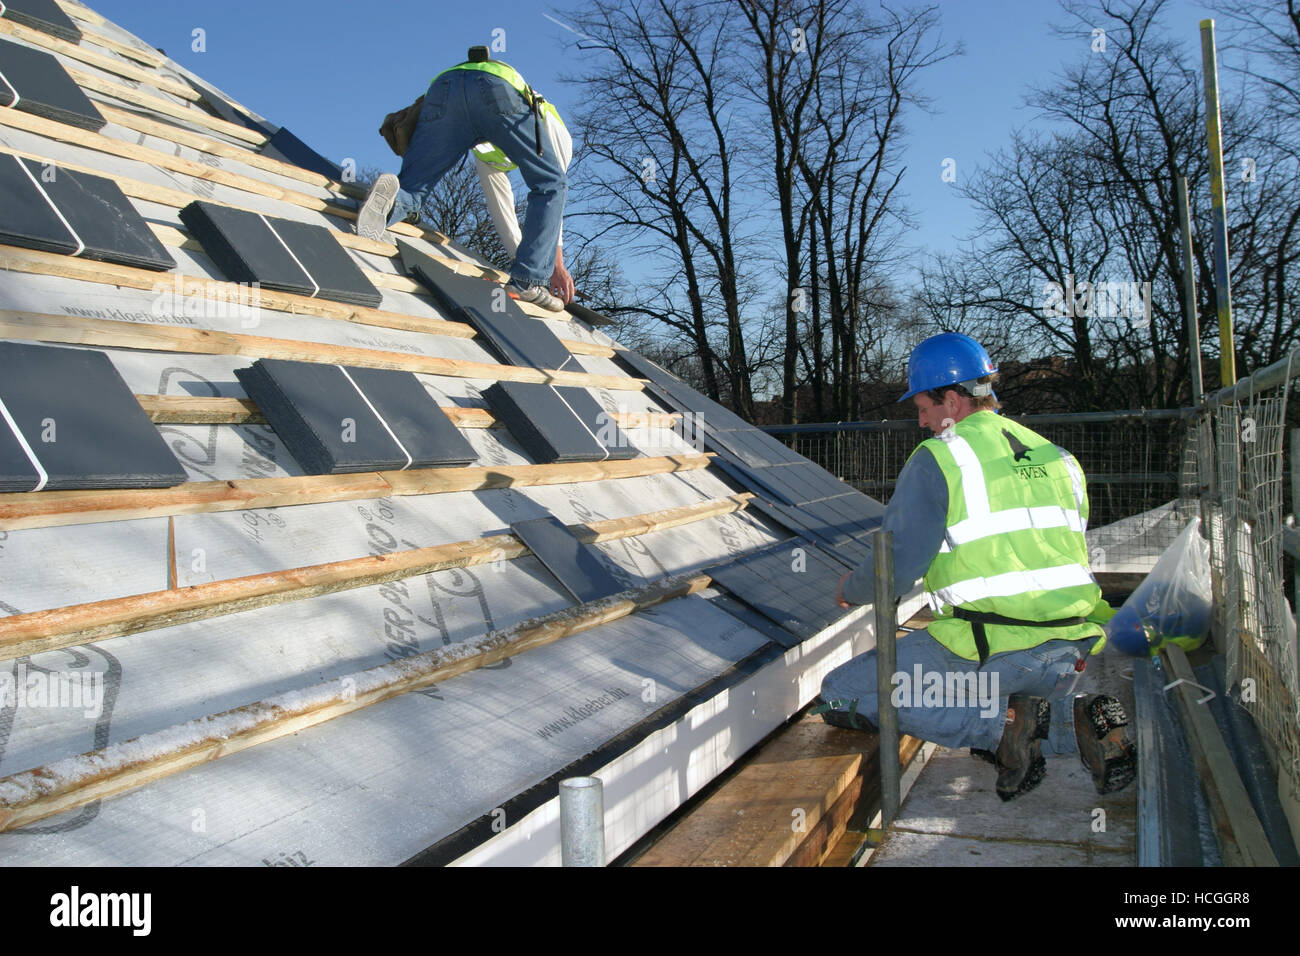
[0,342,186,492]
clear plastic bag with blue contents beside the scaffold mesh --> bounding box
[1106,518,1213,657]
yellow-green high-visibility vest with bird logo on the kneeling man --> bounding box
[918,411,1104,661]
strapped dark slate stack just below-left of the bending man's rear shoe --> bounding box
[181,202,382,308]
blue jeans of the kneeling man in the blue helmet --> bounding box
[822,631,1095,753]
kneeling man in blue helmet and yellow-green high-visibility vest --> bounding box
[816,333,1136,800]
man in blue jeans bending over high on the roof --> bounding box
[356,47,575,311]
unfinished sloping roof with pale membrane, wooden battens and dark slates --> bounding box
[0,0,881,865]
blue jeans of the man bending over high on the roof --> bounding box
[389,70,568,285]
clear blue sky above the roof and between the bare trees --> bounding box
[90,0,1222,269]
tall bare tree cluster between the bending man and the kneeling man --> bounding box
[566,0,950,421]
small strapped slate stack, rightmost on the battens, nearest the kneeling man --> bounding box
[484,381,640,464]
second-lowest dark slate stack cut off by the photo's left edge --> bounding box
[0,155,176,269]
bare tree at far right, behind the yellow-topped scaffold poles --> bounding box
[923,0,1295,408]
